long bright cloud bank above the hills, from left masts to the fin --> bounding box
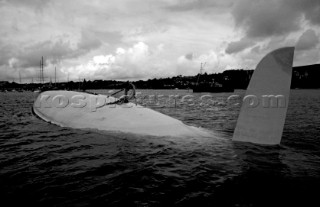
[62,42,239,80]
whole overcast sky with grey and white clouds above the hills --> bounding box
[0,0,320,82]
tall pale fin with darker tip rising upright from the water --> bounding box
[232,47,294,145]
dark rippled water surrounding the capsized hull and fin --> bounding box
[0,90,320,206]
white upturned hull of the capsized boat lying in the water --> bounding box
[33,91,212,137]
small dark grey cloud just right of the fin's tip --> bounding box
[296,29,319,50]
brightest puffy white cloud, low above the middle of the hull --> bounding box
[62,42,172,79]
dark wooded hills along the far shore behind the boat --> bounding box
[0,64,320,91]
